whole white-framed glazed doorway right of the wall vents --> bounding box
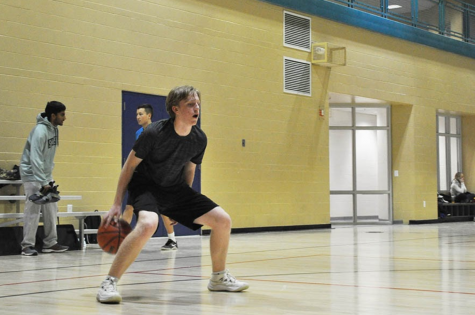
[329,103,393,224]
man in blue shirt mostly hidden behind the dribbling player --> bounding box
[122,104,178,250]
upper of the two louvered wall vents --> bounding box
[284,11,312,51]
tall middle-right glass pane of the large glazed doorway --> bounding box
[356,130,388,190]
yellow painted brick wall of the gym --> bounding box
[0,0,475,228]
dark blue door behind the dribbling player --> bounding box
[122,91,201,236]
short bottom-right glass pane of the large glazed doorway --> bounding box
[356,194,389,222]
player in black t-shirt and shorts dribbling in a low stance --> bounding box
[97,86,249,303]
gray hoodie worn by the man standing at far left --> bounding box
[20,113,59,186]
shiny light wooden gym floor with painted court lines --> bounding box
[0,222,475,315]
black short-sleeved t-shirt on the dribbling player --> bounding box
[133,119,207,187]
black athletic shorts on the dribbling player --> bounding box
[128,184,218,230]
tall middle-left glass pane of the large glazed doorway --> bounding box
[330,130,353,190]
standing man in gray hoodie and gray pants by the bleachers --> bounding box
[20,101,68,256]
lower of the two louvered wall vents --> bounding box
[284,57,312,96]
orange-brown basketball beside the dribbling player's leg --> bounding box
[97,219,132,254]
